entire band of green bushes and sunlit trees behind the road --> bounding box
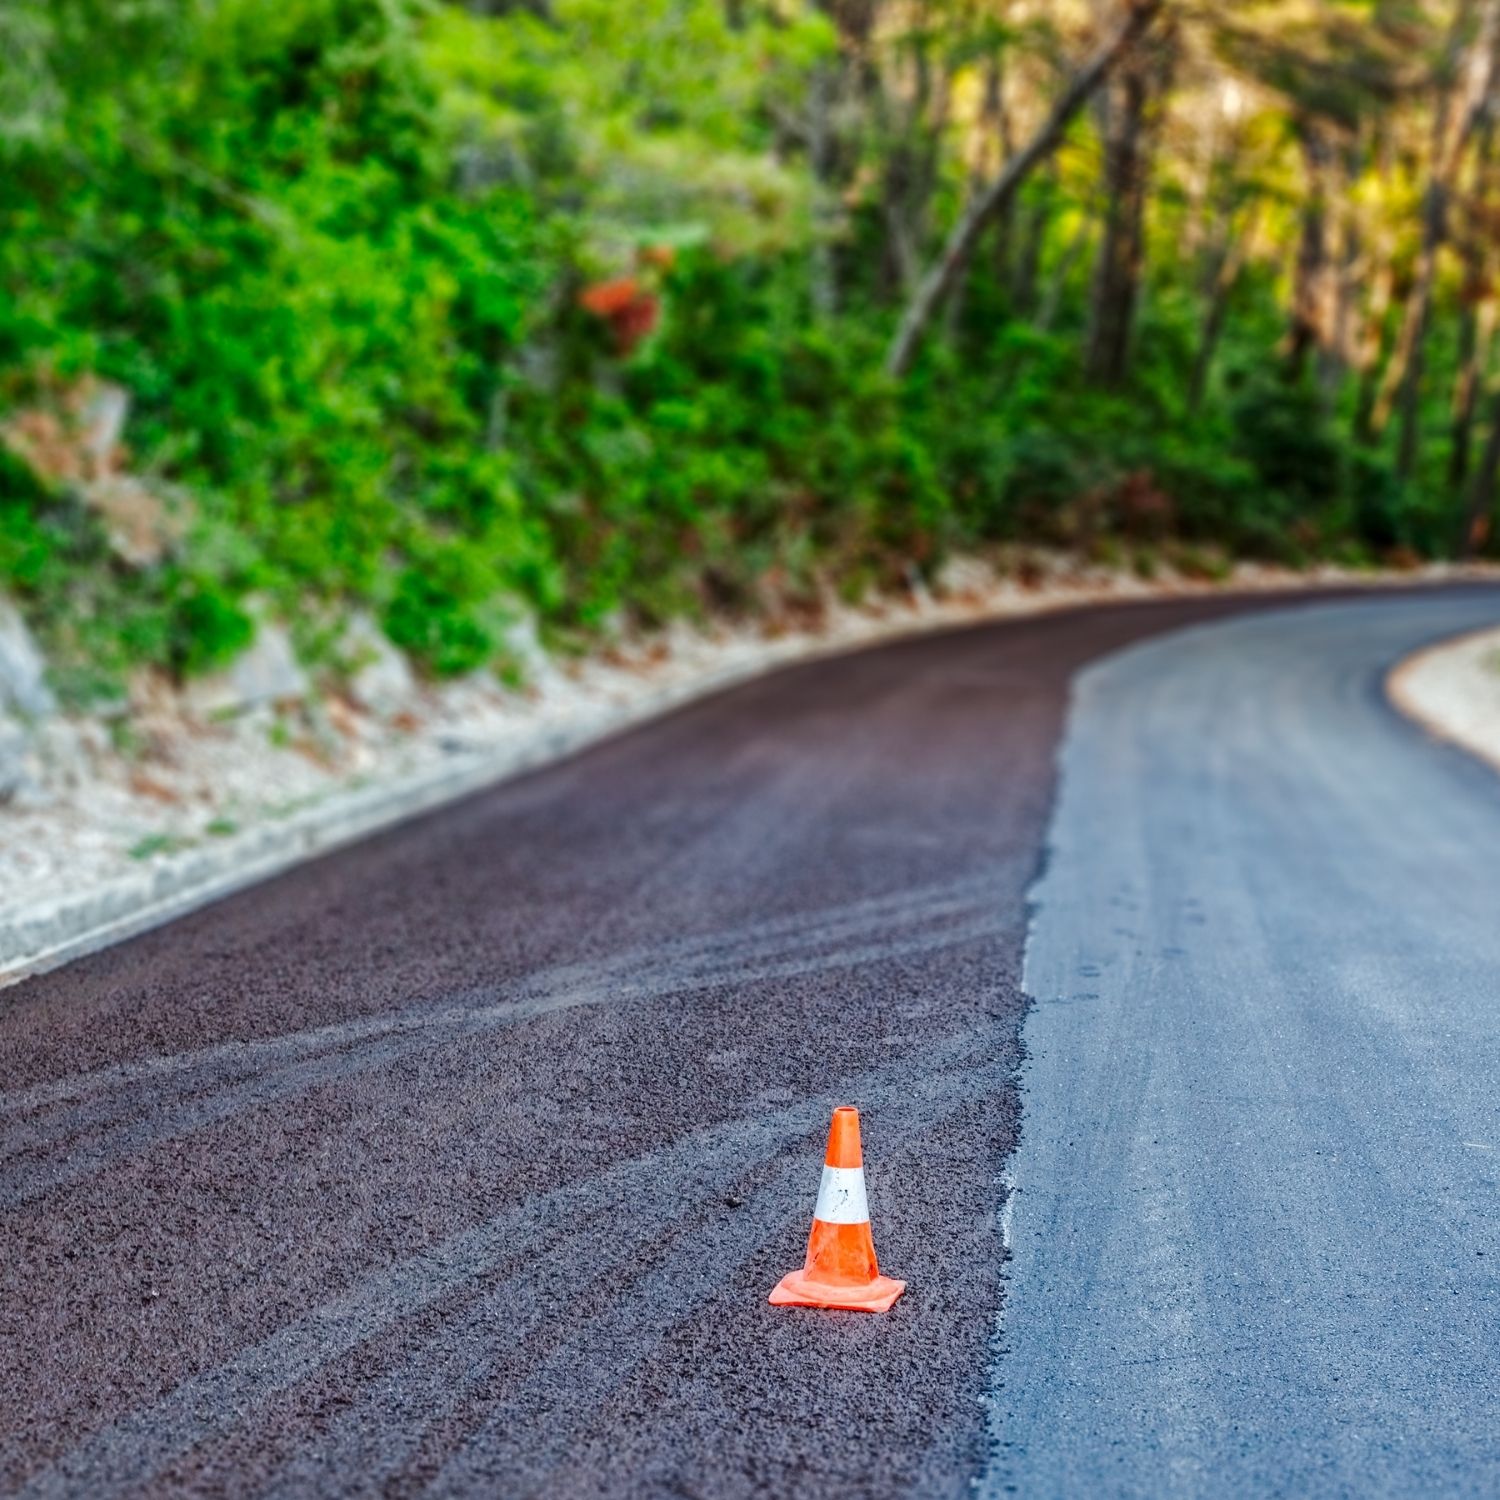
[0,0,1500,698]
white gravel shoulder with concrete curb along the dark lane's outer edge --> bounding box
[0,558,1487,987]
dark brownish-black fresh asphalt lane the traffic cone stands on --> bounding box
[0,596,1494,1496]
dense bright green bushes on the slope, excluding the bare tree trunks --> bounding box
[0,0,1476,690]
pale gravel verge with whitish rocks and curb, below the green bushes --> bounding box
[0,555,1500,984]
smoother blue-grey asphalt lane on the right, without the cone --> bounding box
[981,594,1500,1497]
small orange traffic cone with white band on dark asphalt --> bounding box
[771,1104,906,1313]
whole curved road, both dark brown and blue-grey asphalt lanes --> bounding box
[0,590,1500,1496]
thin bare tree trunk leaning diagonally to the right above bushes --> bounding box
[885,0,1161,377]
